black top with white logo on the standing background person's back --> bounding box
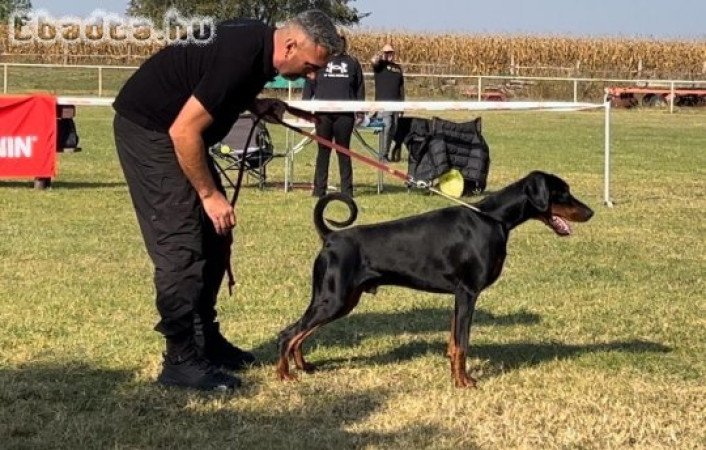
[302,55,365,100]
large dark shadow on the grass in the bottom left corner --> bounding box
[0,362,454,449]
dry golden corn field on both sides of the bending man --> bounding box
[0,26,706,100]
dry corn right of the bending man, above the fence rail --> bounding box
[350,33,706,79]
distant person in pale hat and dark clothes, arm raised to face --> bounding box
[372,44,404,161]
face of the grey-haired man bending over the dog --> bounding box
[275,36,329,80]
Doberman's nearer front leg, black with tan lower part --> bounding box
[448,286,478,387]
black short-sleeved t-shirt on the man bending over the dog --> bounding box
[113,19,276,146]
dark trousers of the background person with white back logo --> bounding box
[314,113,355,197]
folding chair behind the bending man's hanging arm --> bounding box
[209,114,275,189]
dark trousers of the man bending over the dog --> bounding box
[113,114,231,338]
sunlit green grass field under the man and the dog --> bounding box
[0,108,706,449]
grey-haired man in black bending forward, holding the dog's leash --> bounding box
[113,10,341,390]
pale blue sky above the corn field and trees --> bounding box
[27,0,706,42]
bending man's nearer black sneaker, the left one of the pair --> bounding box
[157,355,241,392]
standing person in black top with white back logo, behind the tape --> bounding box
[302,36,365,197]
